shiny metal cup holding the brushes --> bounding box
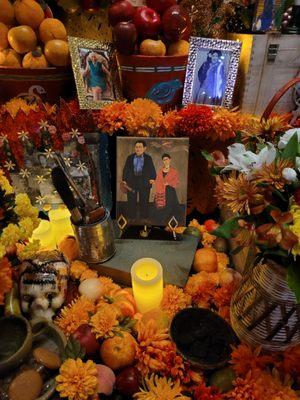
[72,209,116,263]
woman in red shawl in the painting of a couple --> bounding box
[154,153,181,223]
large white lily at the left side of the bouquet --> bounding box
[222,143,276,174]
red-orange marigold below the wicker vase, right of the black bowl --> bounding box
[230,344,274,377]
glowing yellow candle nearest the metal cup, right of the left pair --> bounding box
[49,206,74,245]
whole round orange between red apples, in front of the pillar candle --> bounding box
[100,332,136,370]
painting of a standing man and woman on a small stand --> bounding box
[116,137,189,226]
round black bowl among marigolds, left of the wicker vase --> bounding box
[170,308,238,370]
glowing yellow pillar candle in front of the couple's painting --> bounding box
[131,258,163,313]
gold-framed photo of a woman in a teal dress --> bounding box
[68,36,122,109]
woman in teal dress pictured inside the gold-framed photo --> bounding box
[83,51,112,101]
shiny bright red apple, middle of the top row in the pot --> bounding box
[133,6,161,39]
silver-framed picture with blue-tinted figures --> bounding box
[182,37,242,108]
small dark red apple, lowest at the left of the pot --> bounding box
[113,22,137,56]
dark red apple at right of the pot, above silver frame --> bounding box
[162,6,191,42]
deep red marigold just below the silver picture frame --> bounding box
[177,104,213,137]
